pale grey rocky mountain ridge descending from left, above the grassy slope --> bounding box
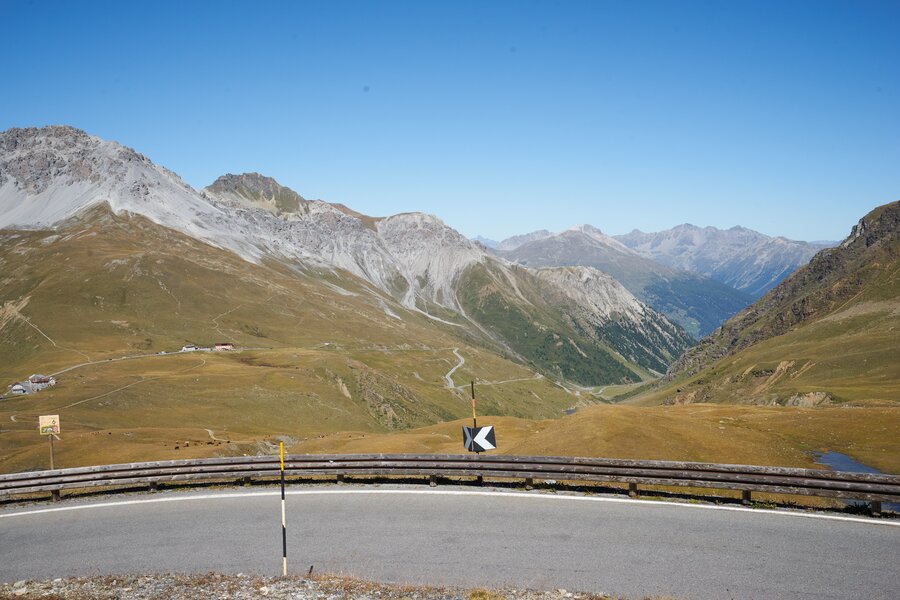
[0,126,692,396]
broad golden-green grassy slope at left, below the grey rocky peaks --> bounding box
[0,207,575,471]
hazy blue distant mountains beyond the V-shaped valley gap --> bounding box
[486,225,836,339]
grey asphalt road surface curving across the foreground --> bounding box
[0,486,900,600]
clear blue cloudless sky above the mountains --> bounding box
[0,0,900,240]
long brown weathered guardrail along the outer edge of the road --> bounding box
[0,454,900,514]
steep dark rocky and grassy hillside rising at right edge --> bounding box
[643,202,900,406]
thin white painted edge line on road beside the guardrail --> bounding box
[0,489,900,527]
